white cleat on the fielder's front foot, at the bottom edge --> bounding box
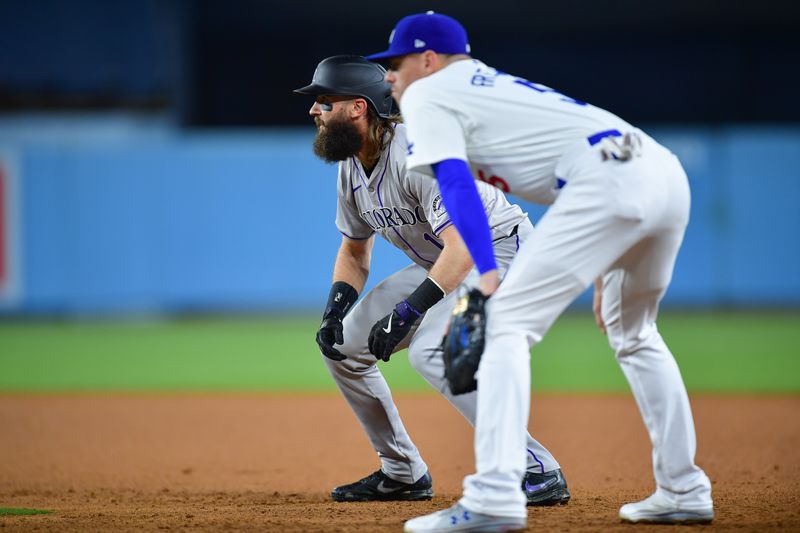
[403,503,528,533]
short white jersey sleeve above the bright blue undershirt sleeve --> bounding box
[400,80,467,172]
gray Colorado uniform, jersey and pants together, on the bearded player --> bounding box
[322,124,559,483]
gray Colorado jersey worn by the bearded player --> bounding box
[336,120,527,262]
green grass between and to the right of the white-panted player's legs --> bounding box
[531,311,800,393]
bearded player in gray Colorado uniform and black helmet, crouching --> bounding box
[295,56,570,505]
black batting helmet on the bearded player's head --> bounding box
[294,55,395,118]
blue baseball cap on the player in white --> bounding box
[367,11,470,60]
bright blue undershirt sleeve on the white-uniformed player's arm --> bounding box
[431,159,497,274]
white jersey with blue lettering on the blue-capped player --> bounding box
[400,59,633,204]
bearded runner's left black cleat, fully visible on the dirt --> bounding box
[331,470,433,502]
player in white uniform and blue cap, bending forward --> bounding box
[368,12,713,533]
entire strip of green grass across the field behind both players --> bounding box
[0,311,800,393]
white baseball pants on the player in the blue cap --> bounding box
[461,133,711,517]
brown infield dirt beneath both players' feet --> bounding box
[0,395,800,533]
